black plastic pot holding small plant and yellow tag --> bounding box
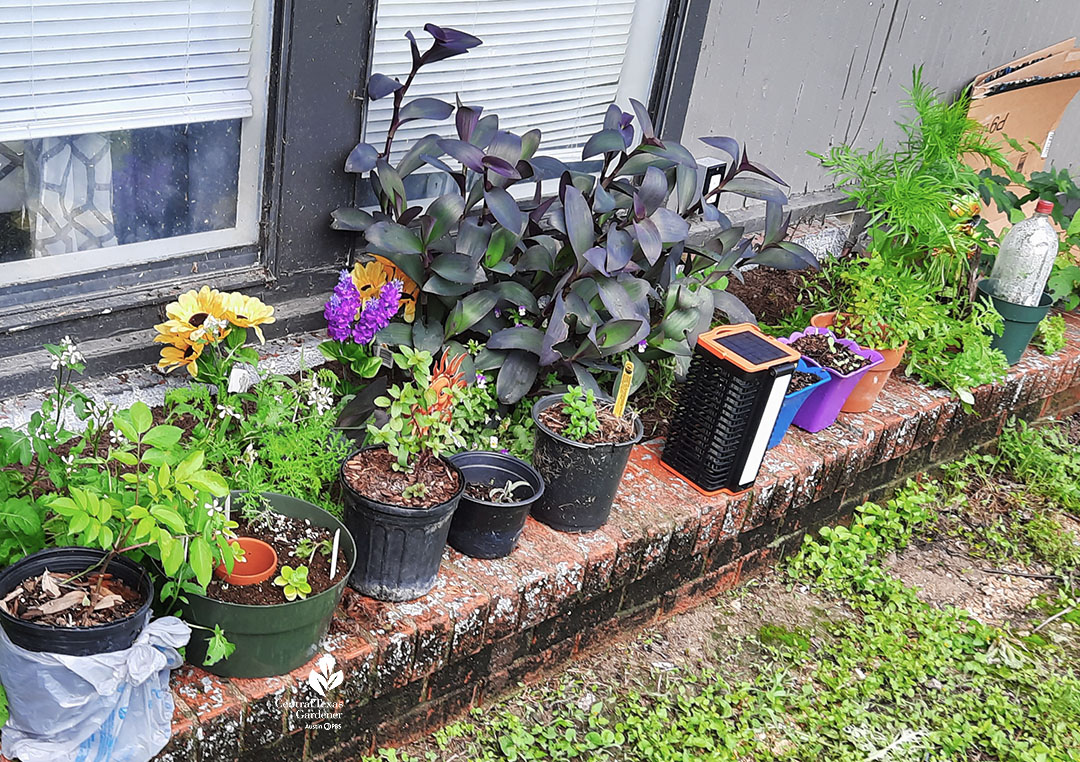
[532,394,645,532]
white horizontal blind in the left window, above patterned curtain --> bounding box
[0,0,255,140]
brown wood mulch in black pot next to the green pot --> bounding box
[345,448,460,508]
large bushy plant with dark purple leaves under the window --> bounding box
[333,25,818,403]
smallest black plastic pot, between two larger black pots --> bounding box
[448,452,544,558]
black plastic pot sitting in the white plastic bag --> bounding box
[0,547,153,656]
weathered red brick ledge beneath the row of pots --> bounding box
[137,308,1080,762]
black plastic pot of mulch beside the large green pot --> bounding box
[338,447,465,601]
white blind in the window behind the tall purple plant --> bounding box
[366,0,662,161]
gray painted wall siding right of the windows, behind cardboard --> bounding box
[664,0,1080,193]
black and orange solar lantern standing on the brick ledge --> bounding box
[661,323,799,495]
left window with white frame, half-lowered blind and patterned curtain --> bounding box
[0,0,273,283]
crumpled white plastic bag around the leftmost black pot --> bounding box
[0,616,191,762]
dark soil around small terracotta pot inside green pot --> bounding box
[206,507,349,605]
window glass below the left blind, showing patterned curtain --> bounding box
[0,120,241,262]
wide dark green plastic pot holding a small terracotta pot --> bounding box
[183,492,356,678]
